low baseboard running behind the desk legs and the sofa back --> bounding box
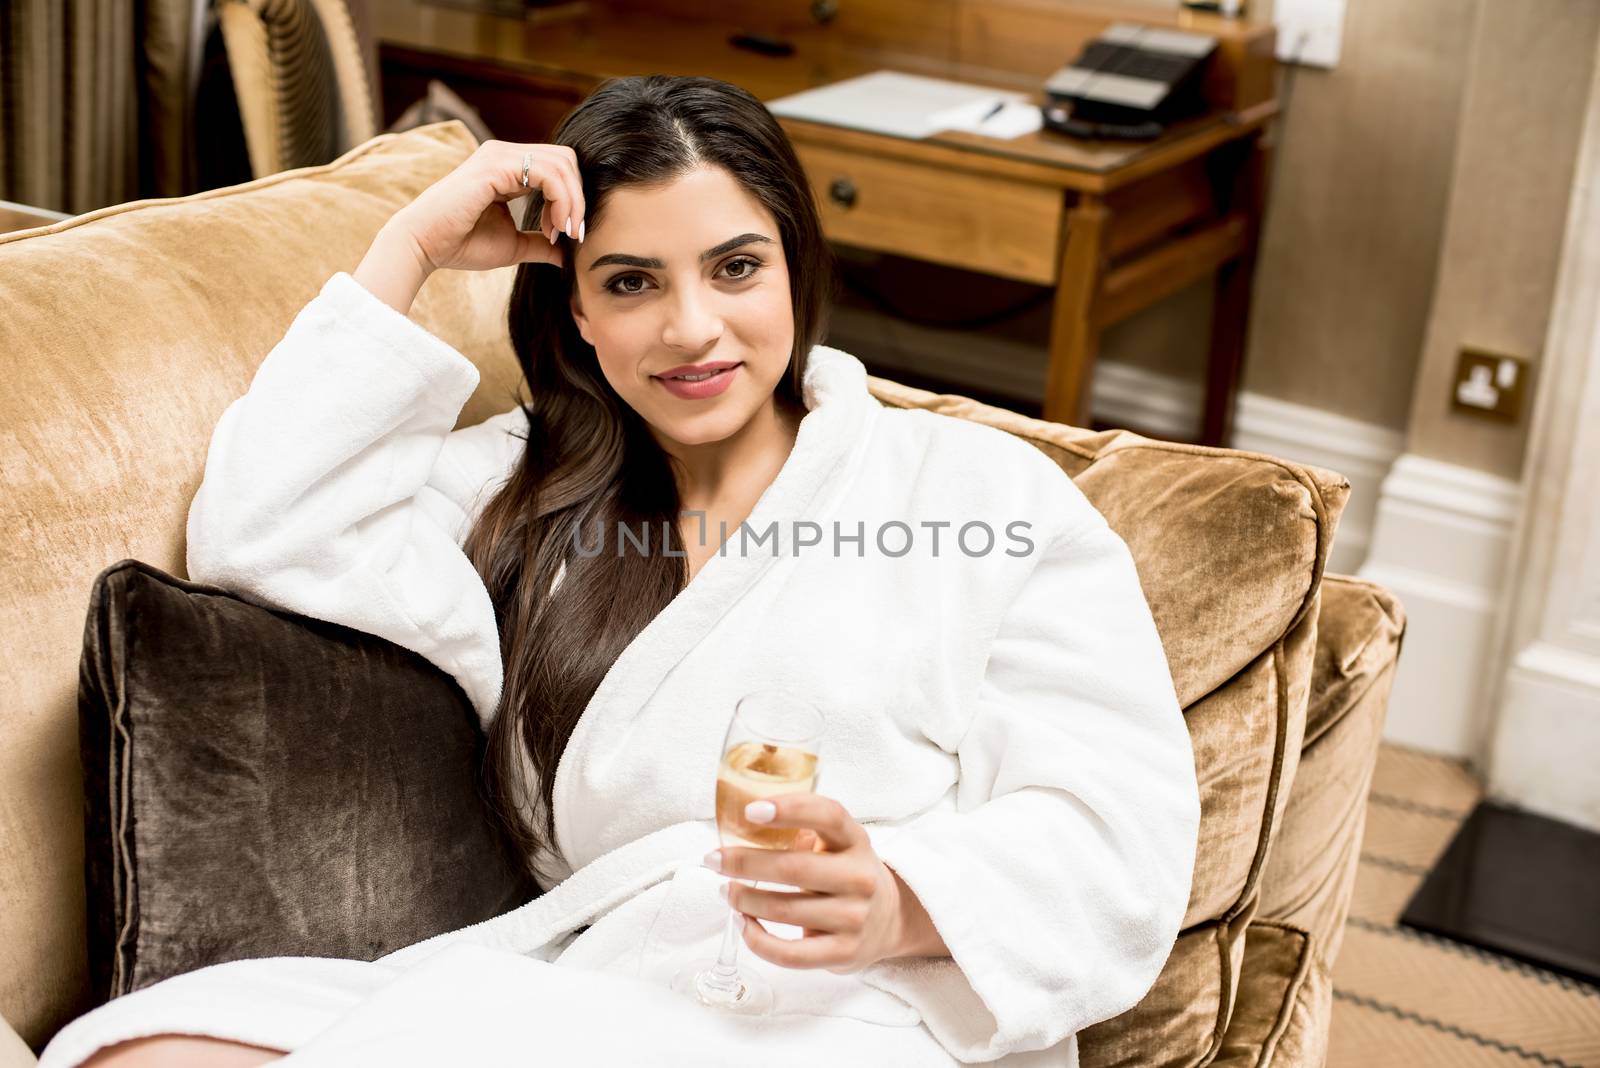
[830,307,1405,574]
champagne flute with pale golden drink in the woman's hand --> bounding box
[672,691,822,1015]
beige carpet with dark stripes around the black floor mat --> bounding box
[1328,745,1600,1068]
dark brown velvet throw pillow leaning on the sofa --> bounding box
[78,560,538,999]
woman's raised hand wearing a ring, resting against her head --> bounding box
[354,141,584,315]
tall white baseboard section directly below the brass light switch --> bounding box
[1360,454,1522,764]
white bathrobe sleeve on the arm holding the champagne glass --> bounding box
[861,498,1200,1062]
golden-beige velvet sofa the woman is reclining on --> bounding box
[0,123,1405,1066]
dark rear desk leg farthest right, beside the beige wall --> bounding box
[1200,134,1267,446]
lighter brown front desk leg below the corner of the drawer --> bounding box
[1045,195,1110,427]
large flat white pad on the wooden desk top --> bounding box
[766,70,1038,137]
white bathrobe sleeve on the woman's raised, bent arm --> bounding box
[187,272,526,724]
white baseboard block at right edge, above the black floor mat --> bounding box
[1488,641,1600,831]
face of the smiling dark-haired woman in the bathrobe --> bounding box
[570,166,794,444]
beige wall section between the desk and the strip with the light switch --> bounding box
[1243,0,1496,430]
